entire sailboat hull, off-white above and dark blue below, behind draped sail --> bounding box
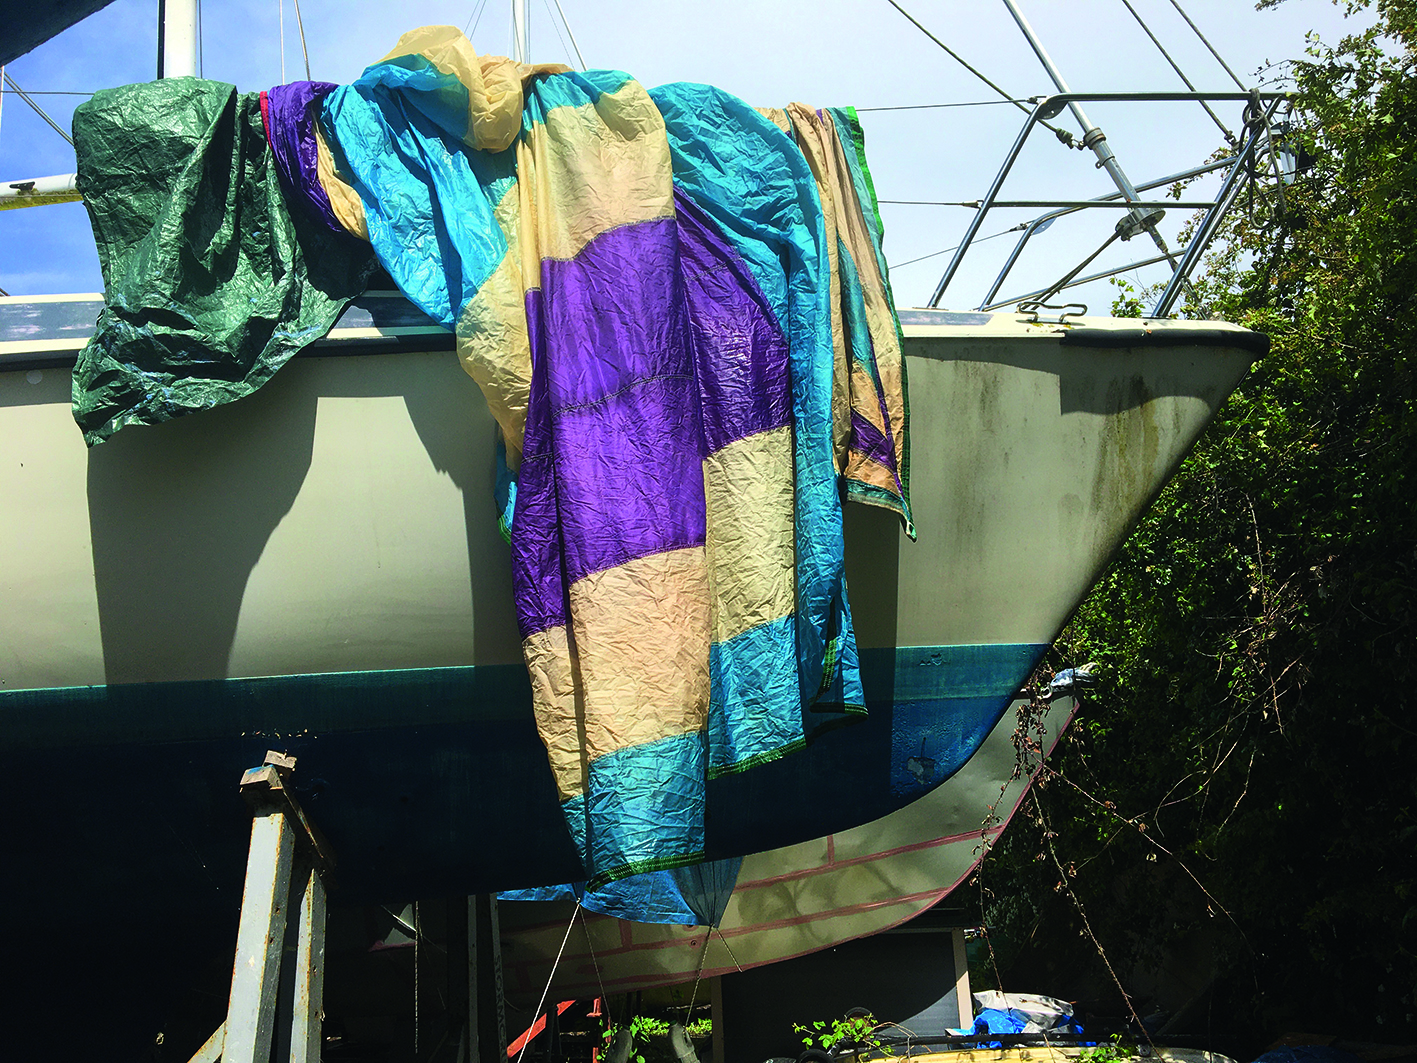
[0,312,1263,900]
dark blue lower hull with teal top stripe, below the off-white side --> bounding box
[0,645,1044,1059]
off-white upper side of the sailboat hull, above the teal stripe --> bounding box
[0,303,1251,692]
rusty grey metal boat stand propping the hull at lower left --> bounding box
[191,751,334,1063]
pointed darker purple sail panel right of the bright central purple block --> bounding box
[674,190,792,454]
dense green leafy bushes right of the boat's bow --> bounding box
[981,0,1417,1057]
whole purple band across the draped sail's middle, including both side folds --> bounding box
[512,196,792,638]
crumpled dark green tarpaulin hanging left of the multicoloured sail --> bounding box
[74,78,376,446]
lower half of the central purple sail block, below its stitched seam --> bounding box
[552,376,707,586]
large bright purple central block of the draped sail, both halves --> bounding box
[532,218,706,584]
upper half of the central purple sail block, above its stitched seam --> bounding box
[541,218,693,410]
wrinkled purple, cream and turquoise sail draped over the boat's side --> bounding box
[322,27,908,921]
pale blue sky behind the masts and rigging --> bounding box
[0,0,1371,313]
